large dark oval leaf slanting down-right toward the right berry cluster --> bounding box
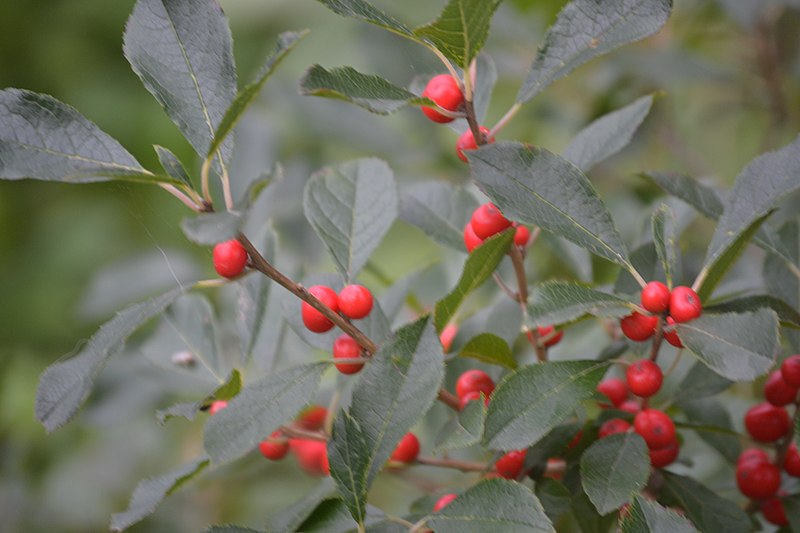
[468,142,632,269]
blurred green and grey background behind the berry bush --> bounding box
[0,0,800,533]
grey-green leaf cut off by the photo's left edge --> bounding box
[0,89,163,183]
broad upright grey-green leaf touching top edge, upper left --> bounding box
[123,0,236,160]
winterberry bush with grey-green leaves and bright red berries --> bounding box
[0,0,800,533]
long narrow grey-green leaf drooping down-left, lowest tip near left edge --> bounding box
[35,289,183,432]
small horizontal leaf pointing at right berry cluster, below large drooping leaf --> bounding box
[528,281,636,326]
